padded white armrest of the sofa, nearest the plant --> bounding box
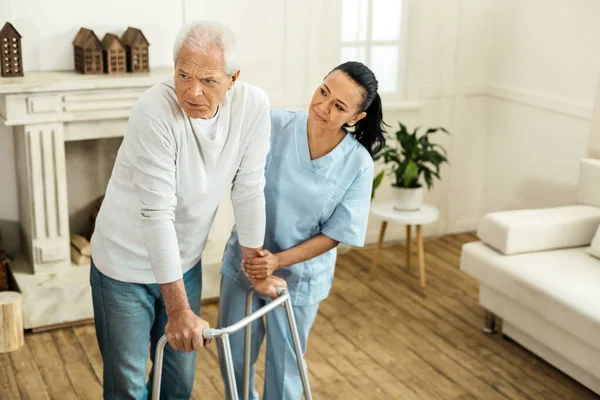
[477,205,600,254]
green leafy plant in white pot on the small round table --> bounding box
[372,123,449,211]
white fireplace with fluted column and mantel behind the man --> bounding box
[0,68,233,329]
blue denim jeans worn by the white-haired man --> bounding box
[90,261,202,400]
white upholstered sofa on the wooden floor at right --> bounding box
[460,159,600,394]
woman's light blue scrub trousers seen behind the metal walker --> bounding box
[217,276,319,400]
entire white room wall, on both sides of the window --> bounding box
[0,0,600,255]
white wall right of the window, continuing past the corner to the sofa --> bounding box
[370,0,600,241]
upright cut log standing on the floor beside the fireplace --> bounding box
[0,291,25,353]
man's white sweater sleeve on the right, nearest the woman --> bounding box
[231,95,271,248]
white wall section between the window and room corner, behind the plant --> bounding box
[369,0,489,242]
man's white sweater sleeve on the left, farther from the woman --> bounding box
[127,109,183,284]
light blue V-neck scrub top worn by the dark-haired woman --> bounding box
[221,110,373,306]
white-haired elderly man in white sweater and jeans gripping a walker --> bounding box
[90,22,285,399]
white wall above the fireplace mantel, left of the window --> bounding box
[8,0,337,106]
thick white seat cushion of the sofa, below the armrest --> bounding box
[460,242,600,349]
